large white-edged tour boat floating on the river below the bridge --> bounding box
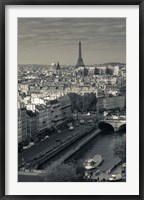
[83,154,103,170]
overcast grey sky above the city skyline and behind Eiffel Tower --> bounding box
[18,18,126,65]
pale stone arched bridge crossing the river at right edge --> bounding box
[98,119,126,131]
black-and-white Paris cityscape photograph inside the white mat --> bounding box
[17,17,127,182]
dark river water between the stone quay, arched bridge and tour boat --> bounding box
[66,130,119,170]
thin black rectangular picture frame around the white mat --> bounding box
[0,0,144,200]
